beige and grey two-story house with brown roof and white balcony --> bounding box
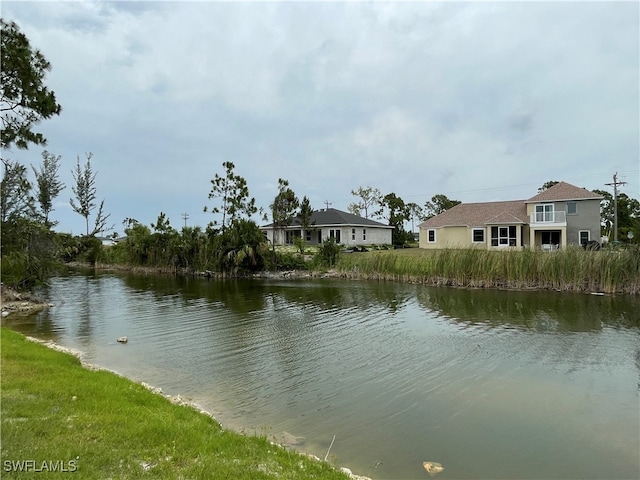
[419,182,602,250]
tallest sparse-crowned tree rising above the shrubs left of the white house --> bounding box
[204,162,258,231]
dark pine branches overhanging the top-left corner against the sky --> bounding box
[0,19,62,153]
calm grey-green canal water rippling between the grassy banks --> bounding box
[5,273,640,479]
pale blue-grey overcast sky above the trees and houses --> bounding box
[2,0,640,234]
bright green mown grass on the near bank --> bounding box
[0,328,347,480]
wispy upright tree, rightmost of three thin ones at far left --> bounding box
[69,153,113,237]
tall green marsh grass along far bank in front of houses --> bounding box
[336,246,640,294]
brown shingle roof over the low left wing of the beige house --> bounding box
[420,200,528,228]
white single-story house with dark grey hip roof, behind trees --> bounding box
[260,208,393,246]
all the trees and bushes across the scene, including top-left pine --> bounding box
[0,19,640,288]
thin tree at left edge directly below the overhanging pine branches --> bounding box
[0,162,35,223]
